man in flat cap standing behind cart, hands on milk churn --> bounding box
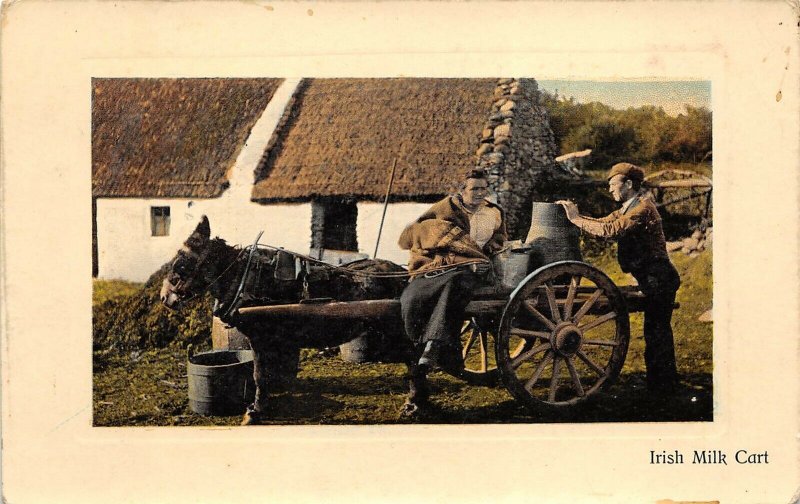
[557,163,680,393]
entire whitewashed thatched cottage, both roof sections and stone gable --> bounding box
[93,78,556,277]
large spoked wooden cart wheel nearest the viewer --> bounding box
[495,261,630,409]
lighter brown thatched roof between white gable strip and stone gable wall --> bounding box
[253,78,497,202]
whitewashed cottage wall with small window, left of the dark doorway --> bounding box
[97,197,311,282]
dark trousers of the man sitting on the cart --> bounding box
[400,268,479,348]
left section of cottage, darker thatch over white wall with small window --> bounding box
[92,79,293,281]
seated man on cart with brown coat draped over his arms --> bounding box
[398,170,507,375]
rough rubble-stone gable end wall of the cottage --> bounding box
[476,79,558,238]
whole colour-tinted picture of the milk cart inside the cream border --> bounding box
[87,76,715,427]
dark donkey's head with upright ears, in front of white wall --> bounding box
[161,215,212,309]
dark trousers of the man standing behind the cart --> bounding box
[631,259,680,390]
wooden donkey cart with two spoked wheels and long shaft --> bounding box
[237,261,644,410]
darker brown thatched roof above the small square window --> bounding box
[92,79,282,197]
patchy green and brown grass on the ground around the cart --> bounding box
[93,243,713,426]
